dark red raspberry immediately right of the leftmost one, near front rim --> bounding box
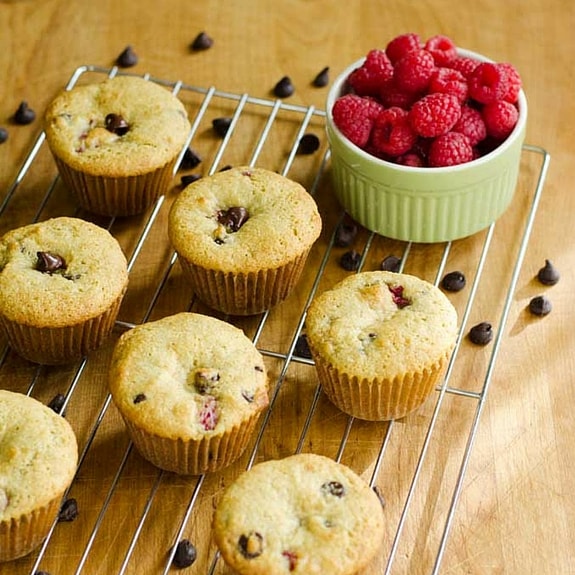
[371,108,417,156]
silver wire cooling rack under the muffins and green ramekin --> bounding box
[0,66,550,575]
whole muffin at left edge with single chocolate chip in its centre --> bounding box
[0,217,128,364]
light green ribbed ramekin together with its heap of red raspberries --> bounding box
[326,33,527,243]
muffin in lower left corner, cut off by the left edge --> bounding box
[0,390,78,562]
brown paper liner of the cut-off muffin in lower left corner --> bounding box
[0,493,64,563]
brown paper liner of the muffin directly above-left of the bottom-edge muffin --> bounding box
[123,412,260,475]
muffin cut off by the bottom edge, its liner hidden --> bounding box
[213,453,384,575]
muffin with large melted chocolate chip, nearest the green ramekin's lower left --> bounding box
[168,167,321,315]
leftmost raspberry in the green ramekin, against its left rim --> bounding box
[332,94,382,148]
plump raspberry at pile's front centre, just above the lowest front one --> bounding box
[409,93,461,138]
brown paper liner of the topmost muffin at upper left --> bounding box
[54,156,177,216]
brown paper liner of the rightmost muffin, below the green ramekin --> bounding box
[311,349,450,421]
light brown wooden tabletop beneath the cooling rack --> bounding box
[0,0,575,575]
